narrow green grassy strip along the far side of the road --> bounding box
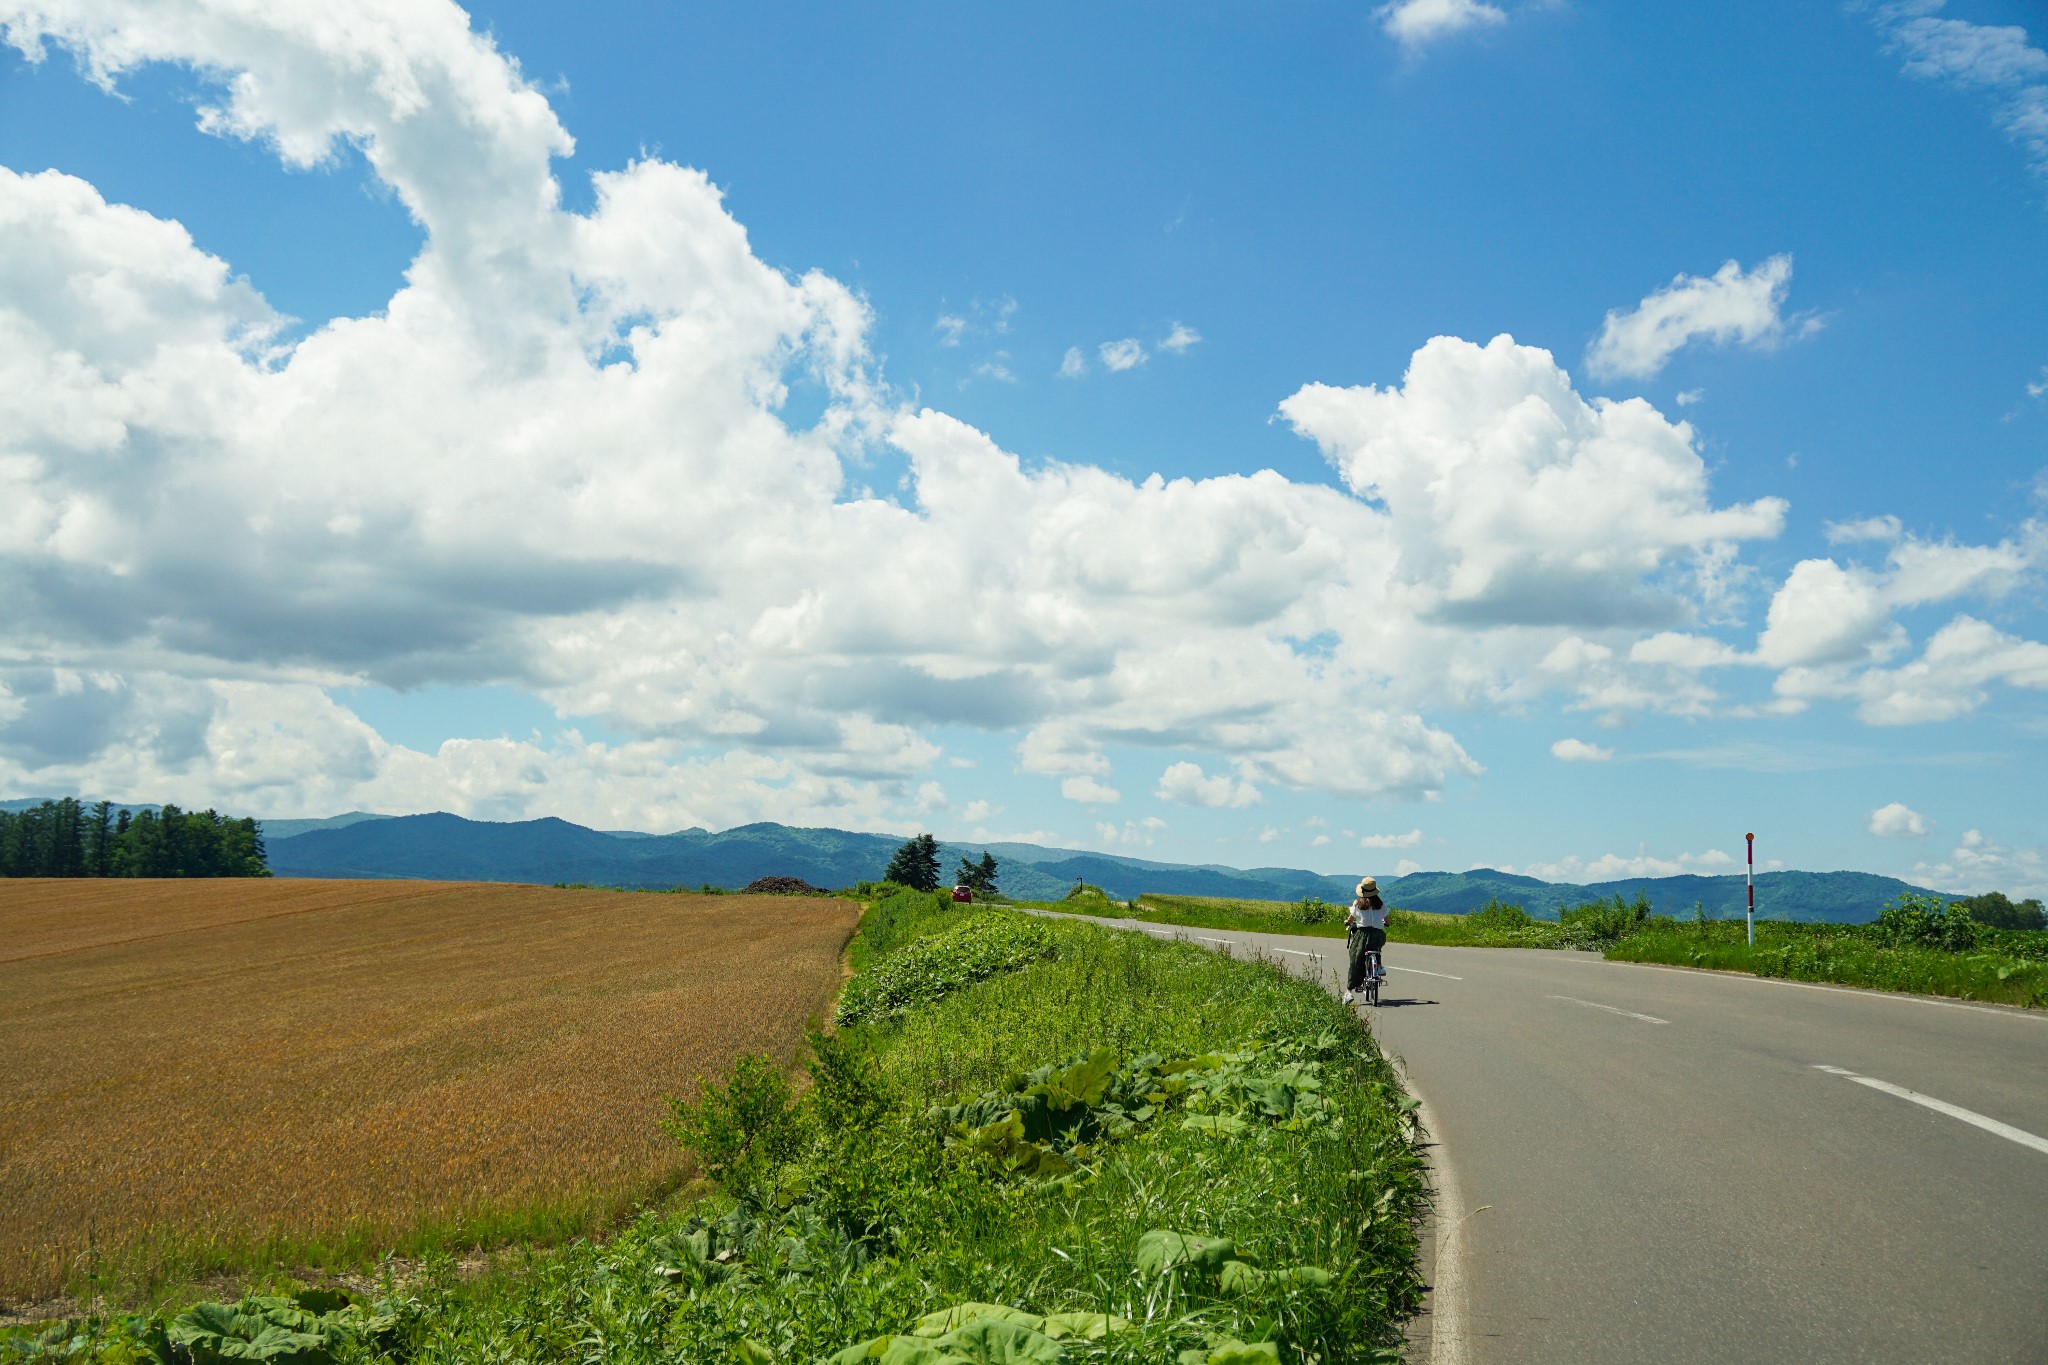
[1047,894,2048,1007]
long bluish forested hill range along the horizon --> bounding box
[251,812,1921,923]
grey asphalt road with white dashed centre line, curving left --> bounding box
[1048,921,2048,1365]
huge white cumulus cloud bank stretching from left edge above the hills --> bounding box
[0,0,1925,829]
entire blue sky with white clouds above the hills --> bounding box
[0,0,2048,894]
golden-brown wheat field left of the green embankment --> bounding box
[0,880,858,1302]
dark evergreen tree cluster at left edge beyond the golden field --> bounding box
[0,796,270,876]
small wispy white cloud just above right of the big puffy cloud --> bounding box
[1585,256,1819,379]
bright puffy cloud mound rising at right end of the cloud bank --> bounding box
[1280,336,1786,628]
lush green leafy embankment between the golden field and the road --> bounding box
[12,892,1423,1365]
